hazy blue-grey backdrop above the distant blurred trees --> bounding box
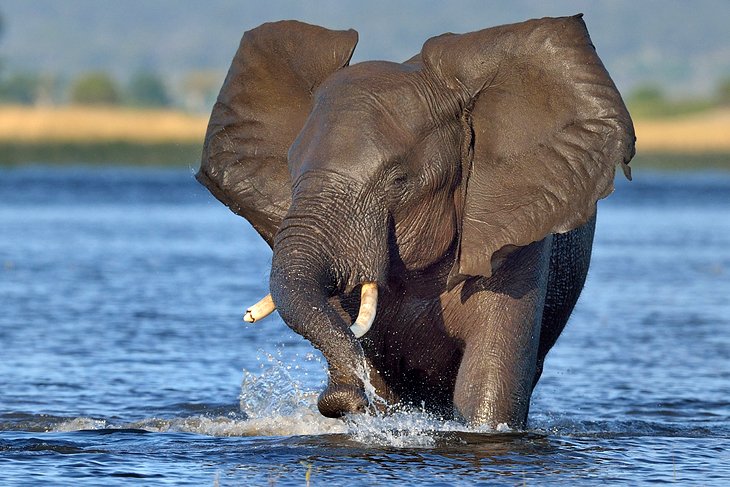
[0,0,730,92]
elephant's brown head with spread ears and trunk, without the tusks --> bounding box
[198,16,634,416]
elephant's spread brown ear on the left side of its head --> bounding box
[197,21,357,246]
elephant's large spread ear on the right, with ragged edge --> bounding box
[422,15,635,286]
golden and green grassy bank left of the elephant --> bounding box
[0,106,208,166]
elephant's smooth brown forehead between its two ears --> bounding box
[289,62,432,180]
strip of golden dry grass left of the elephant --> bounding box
[0,106,208,144]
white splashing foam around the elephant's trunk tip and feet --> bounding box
[45,355,511,448]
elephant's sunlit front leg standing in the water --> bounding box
[454,237,552,428]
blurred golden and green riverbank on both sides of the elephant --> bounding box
[0,106,730,170]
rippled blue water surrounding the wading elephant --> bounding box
[0,167,730,485]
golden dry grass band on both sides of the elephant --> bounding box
[0,106,730,153]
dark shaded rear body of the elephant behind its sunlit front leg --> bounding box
[532,215,596,388]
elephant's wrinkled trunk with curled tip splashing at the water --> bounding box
[270,189,387,417]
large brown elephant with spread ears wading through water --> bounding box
[196,14,635,428]
